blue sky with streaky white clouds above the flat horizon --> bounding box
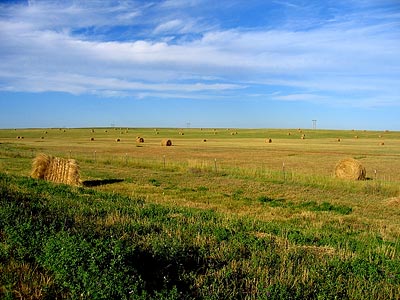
[0,0,400,130]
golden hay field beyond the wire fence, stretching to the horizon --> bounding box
[0,128,400,181]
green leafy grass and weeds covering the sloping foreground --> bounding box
[0,174,400,299]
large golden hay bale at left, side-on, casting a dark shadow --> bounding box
[31,153,81,185]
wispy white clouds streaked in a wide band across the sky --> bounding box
[0,0,400,106]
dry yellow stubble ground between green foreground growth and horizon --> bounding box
[0,128,400,221]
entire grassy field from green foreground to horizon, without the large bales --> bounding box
[0,128,400,299]
